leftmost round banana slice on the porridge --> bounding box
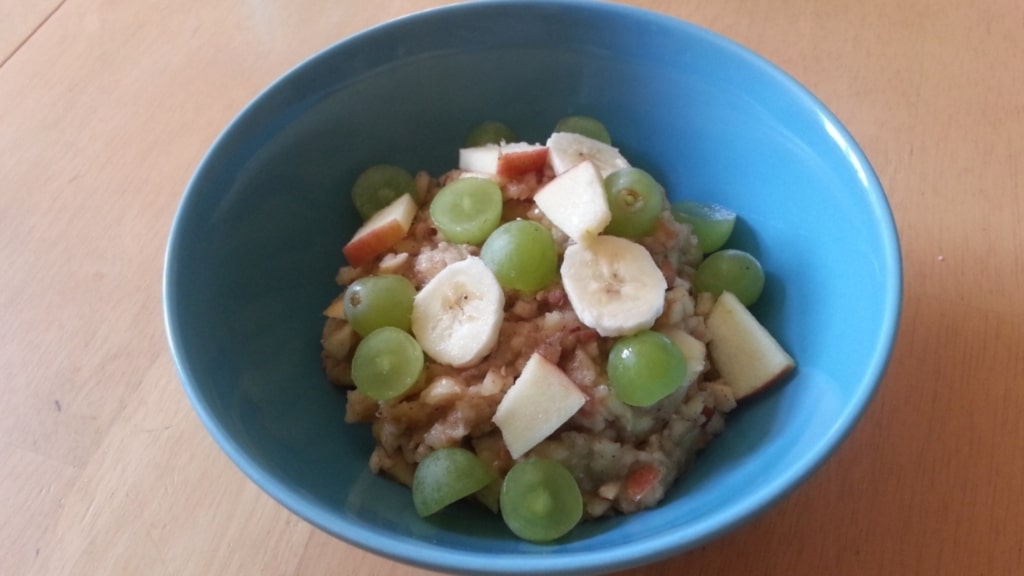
[413,256,505,368]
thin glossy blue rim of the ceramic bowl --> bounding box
[162,0,903,574]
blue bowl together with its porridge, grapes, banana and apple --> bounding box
[164,1,901,574]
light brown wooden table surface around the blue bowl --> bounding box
[0,0,1024,576]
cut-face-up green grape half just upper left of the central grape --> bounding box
[430,178,503,246]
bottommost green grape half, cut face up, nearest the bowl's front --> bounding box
[500,458,583,542]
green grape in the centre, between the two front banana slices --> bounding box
[480,220,558,292]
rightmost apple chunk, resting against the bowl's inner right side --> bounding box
[707,291,797,400]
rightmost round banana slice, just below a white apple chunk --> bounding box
[561,236,668,336]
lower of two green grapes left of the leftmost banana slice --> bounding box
[352,326,423,400]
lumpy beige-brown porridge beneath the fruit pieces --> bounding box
[322,163,736,518]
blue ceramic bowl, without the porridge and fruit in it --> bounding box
[164,1,901,574]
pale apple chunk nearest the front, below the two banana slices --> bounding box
[493,353,587,458]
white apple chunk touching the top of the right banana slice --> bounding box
[534,160,611,242]
